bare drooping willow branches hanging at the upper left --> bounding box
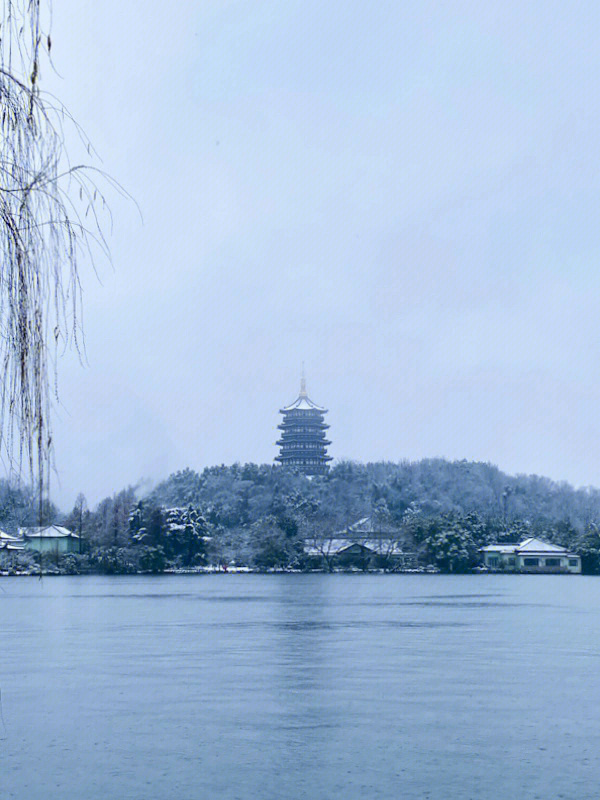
[0,0,112,504]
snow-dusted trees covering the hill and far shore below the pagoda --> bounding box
[0,459,600,573]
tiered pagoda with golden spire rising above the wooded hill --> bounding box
[275,371,331,475]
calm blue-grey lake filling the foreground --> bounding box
[0,574,600,800]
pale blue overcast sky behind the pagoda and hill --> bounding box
[43,0,600,508]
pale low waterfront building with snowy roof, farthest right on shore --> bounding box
[480,537,581,574]
